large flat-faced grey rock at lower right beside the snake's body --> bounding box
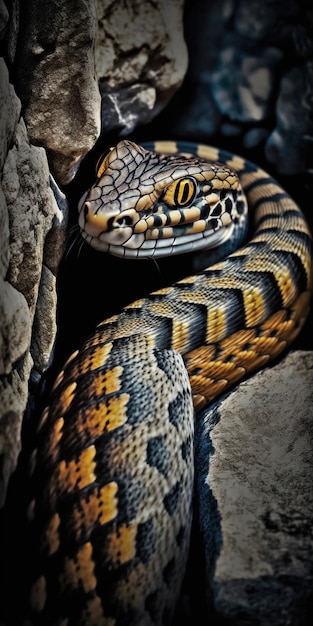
[199,351,313,626]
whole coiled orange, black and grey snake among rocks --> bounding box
[23,139,312,626]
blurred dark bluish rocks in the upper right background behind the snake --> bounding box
[165,0,313,175]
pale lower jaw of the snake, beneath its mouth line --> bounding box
[81,222,234,259]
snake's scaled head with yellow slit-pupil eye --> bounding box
[78,140,247,258]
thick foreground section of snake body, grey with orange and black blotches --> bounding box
[28,342,193,626]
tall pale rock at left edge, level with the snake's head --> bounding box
[2,120,57,316]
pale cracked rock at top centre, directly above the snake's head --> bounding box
[95,0,188,134]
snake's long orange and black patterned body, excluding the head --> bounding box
[28,142,312,626]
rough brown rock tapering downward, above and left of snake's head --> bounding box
[15,0,100,184]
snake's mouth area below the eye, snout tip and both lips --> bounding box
[78,193,239,258]
